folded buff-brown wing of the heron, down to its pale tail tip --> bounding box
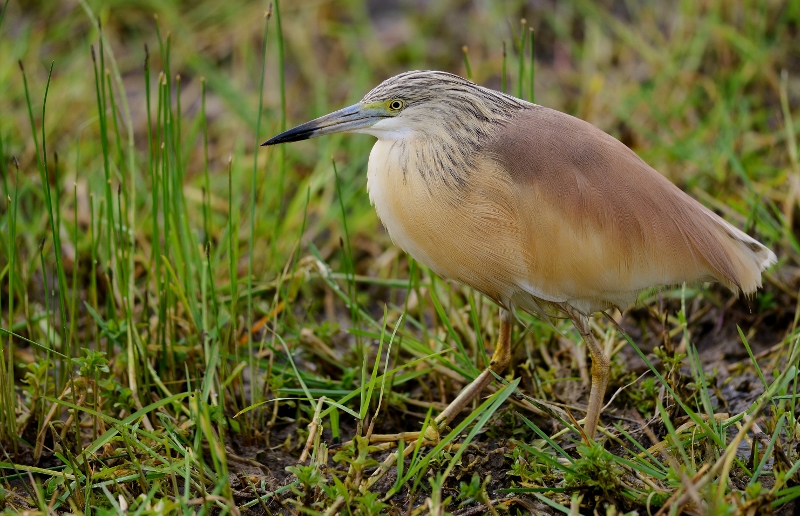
[484,106,775,311]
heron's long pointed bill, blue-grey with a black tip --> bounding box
[261,103,391,147]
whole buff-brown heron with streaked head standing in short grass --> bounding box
[263,71,776,439]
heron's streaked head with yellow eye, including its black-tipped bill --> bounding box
[262,70,530,145]
